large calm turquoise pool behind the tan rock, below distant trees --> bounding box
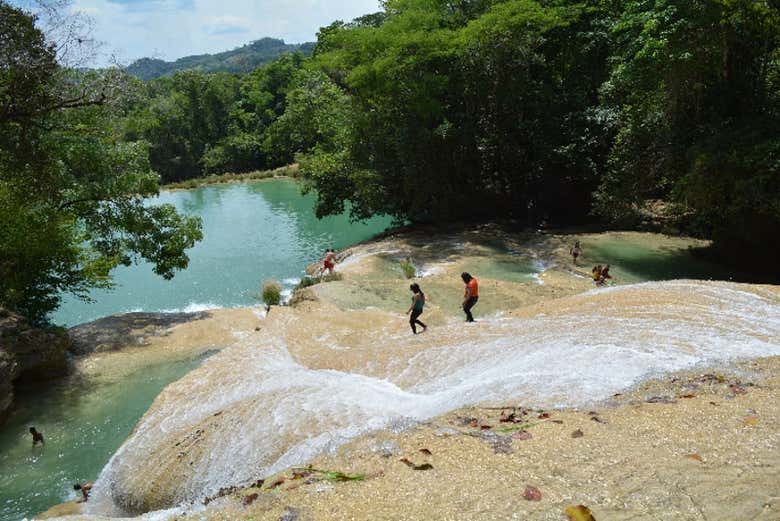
[52,179,390,326]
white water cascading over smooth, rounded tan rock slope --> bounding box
[89,281,780,514]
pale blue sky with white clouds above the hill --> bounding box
[10,0,379,66]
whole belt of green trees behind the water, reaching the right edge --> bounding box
[126,0,780,268]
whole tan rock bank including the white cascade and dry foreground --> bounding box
[27,228,780,520]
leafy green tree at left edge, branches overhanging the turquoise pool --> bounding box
[0,1,202,322]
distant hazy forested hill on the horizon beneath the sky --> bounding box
[127,38,314,80]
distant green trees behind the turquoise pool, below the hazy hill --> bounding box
[124,53,304,183]
